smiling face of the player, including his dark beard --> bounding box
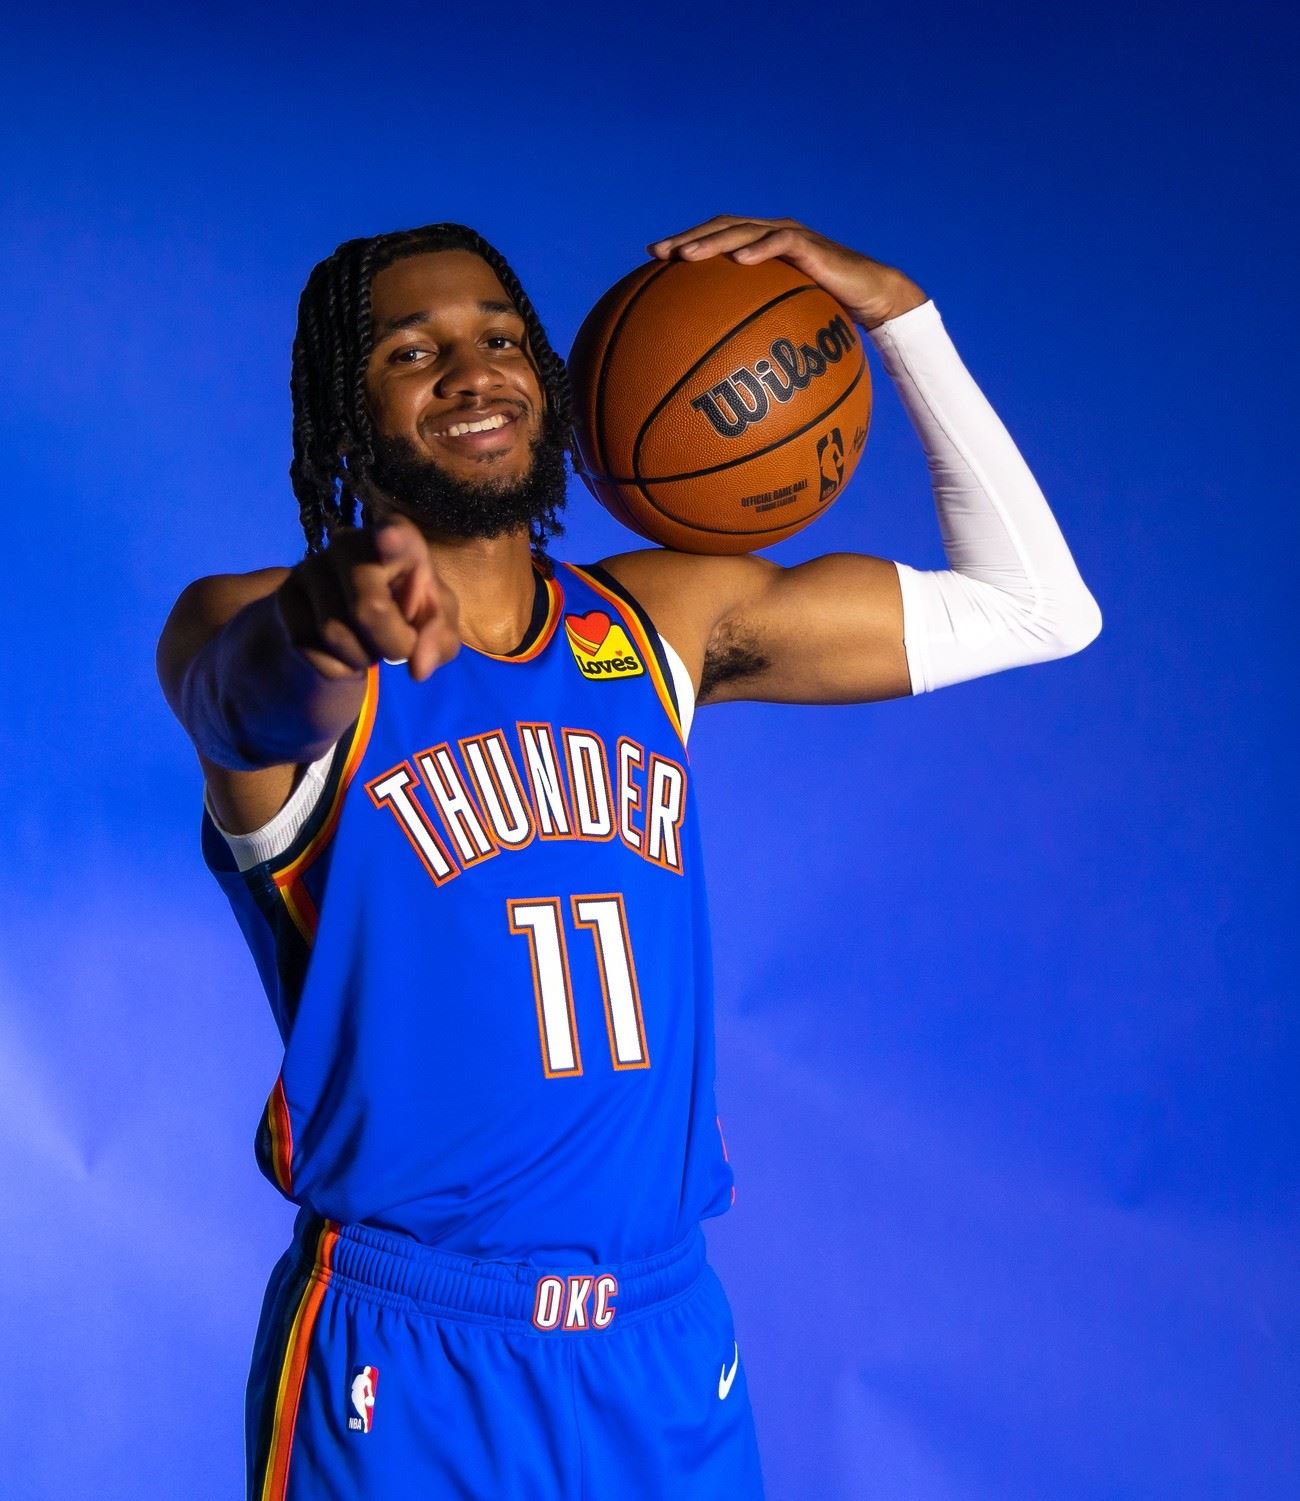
[366,251,564,537]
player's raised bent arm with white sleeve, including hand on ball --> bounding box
[611,216,1100,704]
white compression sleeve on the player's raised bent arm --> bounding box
[869,302,1102,693]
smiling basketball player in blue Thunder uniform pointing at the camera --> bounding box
[159,216,1100,1501]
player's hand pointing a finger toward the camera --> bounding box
[278,516,461,681]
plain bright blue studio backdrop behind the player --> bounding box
[0,3,1300,1501]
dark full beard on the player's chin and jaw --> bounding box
[371,429,566,537]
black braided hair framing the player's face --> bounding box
[288,224,575,573]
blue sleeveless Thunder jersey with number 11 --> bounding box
[204,564,731,1262]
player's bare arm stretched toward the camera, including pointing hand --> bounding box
[158,521,459,833]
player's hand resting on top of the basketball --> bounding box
[645,213,926,329]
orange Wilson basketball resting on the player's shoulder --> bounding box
[569,255,871,552]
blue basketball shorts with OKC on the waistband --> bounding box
[246,1211,763,1501]
